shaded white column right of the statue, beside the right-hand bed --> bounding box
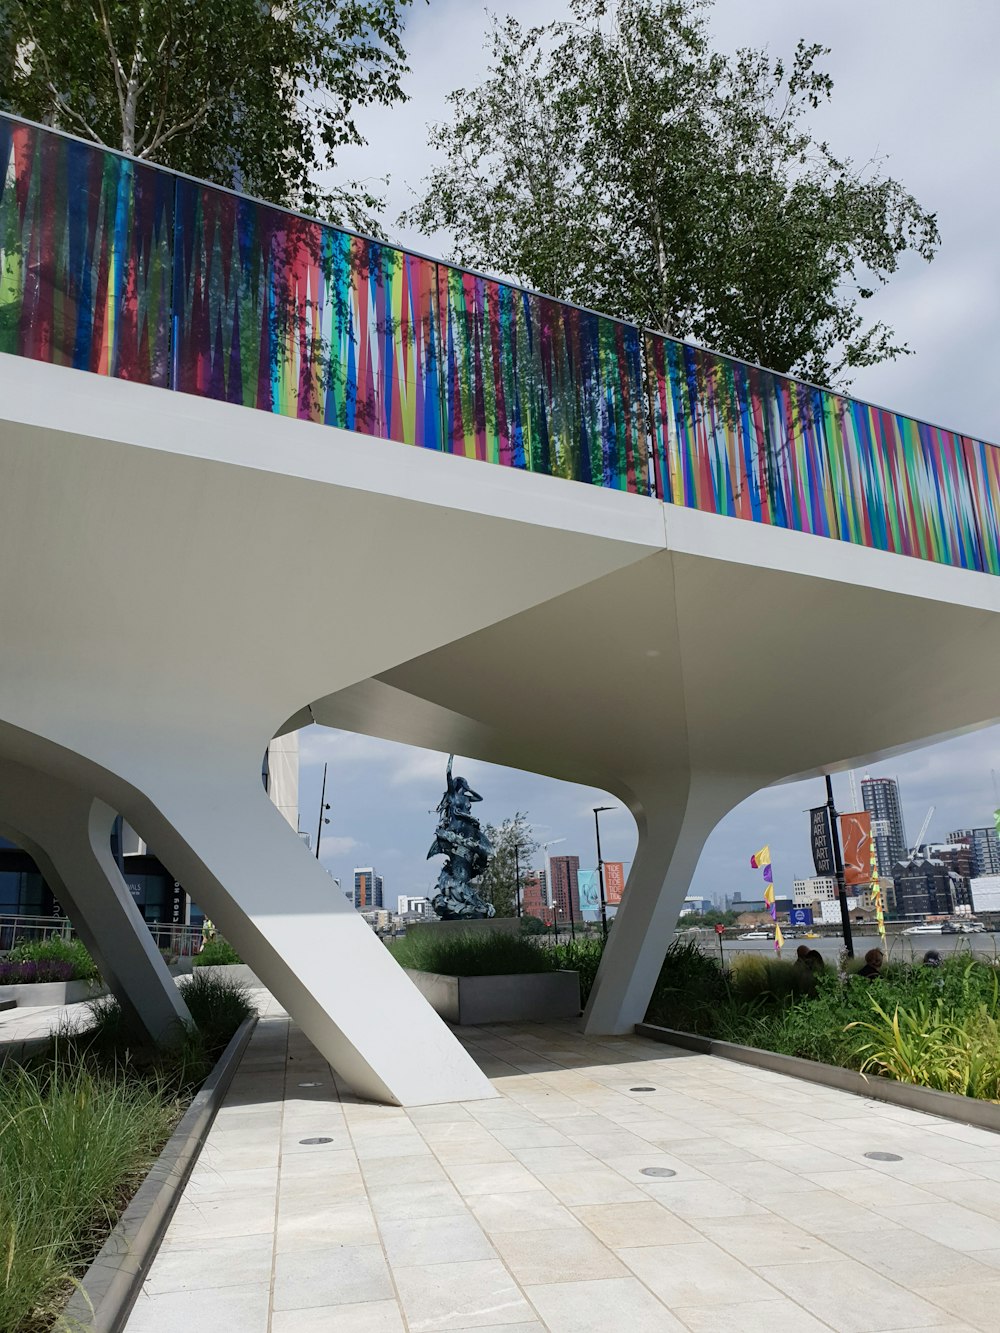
[584,774,767,1034]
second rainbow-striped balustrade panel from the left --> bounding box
[173,180,440,448]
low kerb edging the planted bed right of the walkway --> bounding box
[636,1022,1000,1133]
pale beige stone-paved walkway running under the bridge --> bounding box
[128,997,1000,1333]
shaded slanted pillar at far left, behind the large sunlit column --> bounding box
[0,761,191,1041]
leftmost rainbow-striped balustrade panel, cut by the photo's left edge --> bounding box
[0,116,173,388]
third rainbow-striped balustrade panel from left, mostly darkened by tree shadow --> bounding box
[437,264,649,495]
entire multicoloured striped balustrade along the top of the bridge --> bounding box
[0,116,1000,575]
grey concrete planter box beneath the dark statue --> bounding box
[404,968,580,1026]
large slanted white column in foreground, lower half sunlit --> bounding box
[129,767,496,1106]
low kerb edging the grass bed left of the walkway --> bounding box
[55,1017,257,1333]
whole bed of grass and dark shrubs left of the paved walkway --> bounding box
[0,974,253,1333]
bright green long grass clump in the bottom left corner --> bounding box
[0,1057,179,1333]
